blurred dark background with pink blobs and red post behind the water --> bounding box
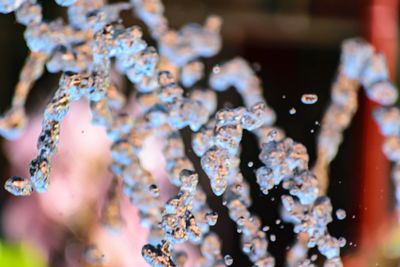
[0,0,400,267]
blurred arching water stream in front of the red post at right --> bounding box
[315,39,400,224]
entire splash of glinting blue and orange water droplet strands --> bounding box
[0,0,394,267]
